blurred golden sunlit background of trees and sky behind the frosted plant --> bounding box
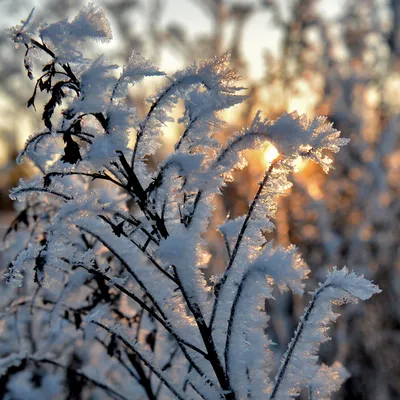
[0,0,400,400]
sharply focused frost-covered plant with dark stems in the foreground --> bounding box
[0,4,379,400]
